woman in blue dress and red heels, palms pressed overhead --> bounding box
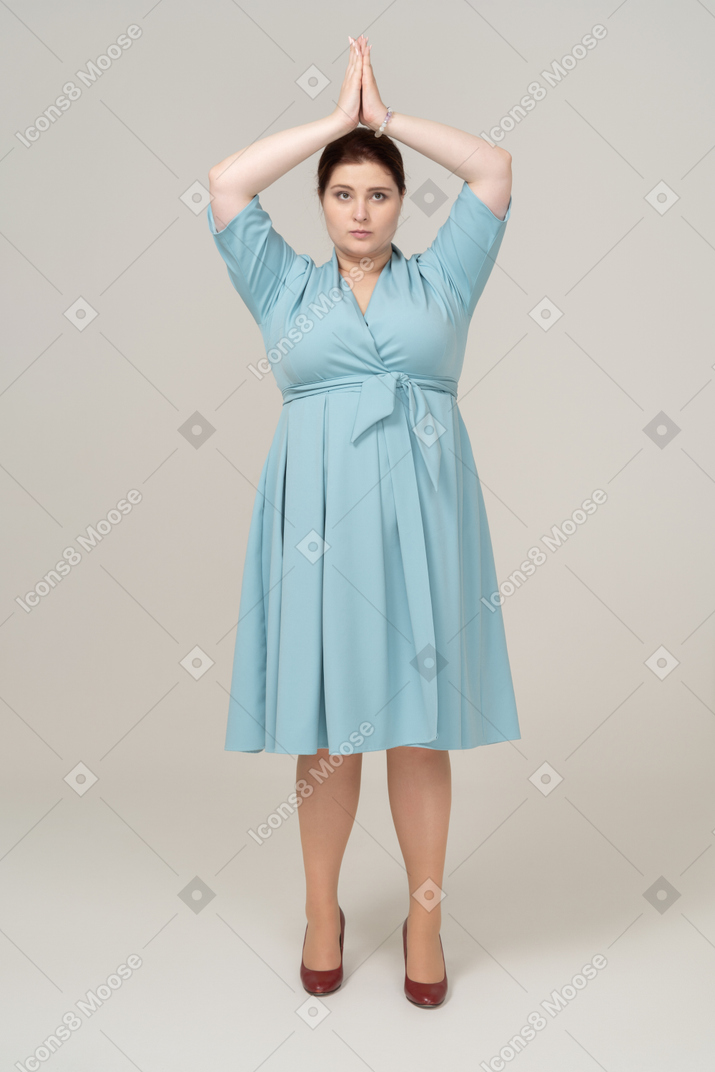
[208,36,521,1008]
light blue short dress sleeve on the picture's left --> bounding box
[207,194,298,325]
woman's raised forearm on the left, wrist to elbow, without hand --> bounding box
[209,111,352,197]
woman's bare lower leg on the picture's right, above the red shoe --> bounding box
[387,745,451,983]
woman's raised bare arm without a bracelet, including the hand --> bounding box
[209,39,362,230]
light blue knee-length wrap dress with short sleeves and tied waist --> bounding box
[207,182,521,755]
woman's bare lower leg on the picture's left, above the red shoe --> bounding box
[296,748,362,971]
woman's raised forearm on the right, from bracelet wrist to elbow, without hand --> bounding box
[371,111,511,182]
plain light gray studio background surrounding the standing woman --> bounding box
[0,0,715,1072]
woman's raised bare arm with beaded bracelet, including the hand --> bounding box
[358,38,511,219]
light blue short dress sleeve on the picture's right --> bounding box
[419,181,511,316]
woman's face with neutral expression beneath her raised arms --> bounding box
[323,161,404,260]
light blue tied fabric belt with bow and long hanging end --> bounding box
[283,372,458,744]
